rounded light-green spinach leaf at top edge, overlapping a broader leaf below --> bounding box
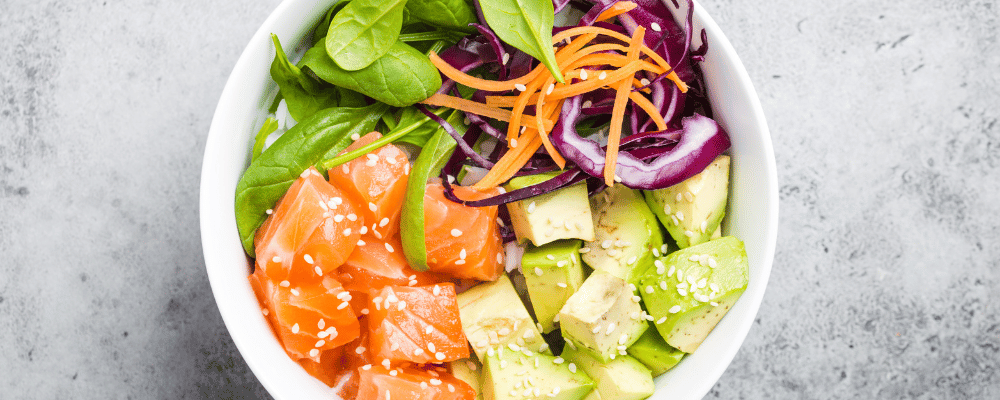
[326,0,406,71]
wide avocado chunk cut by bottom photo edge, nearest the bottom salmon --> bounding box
[482,350,594,400]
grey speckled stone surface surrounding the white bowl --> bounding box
[0,0,1000,399]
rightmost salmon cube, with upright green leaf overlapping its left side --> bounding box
[424,182,504,281]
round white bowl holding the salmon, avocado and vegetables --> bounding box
[200,0,778,399]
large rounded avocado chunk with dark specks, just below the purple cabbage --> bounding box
[583,185,663,282]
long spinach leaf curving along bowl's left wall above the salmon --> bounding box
[236,103,389,256]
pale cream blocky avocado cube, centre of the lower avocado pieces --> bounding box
[558,271,648,362]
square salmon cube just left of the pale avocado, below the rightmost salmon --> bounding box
[368,283,469,363]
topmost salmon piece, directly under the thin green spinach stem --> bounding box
[329,132,410,239]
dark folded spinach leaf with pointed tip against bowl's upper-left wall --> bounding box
[271,34,340,121]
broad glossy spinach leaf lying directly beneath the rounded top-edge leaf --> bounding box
[299,38,441,107]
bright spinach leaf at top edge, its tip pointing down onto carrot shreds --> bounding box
[479,0,563,83]
